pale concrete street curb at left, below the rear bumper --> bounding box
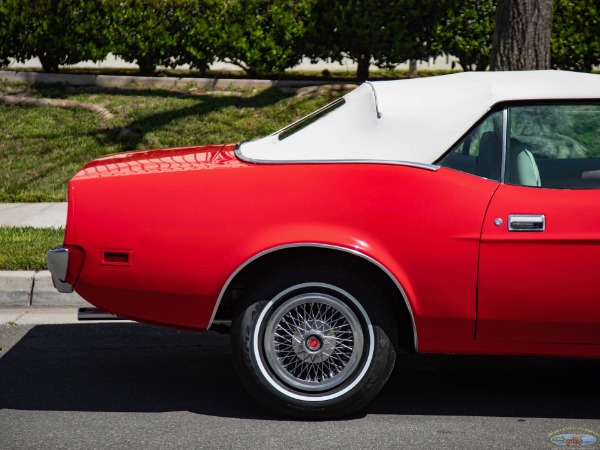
[0,270,92,308]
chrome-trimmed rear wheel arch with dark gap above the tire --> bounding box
[209,243,418,351]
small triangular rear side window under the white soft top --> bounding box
[439,111,502,181]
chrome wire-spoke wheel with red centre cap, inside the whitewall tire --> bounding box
[263,292,364,392]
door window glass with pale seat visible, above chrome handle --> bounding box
[506,104,600,189]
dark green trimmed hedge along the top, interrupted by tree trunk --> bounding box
[0,0,600,79]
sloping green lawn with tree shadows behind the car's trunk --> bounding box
[0,83,341,202]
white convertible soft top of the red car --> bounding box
[237,70,600,164]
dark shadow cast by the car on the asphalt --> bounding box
[0,323,600,419]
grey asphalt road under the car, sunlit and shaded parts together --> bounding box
[0,323,600,450]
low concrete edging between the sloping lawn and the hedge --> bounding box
[0,70,348,90]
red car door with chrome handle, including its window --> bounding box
[476,103,600,344]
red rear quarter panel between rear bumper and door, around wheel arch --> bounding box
[71,152,497,345]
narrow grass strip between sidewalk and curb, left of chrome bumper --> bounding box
[0,227,64,270]
